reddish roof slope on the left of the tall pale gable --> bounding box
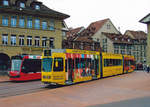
[87,19,109,33]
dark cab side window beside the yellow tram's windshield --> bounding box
[53,58,64,72]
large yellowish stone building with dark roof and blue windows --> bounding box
[0,0,69,69]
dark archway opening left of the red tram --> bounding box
[0,53,11,70]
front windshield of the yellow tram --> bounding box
[42,58,52,72]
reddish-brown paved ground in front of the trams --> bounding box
[0,72,150,107]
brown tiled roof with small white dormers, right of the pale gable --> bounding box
[103,33,132,44]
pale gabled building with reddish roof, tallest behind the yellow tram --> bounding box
[84,19,120,53]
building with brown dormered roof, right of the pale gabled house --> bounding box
[102,33,132,55]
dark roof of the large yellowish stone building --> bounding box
[0,0,70,19]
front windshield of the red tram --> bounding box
[11,59,22,71]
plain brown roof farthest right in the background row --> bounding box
[126,30,147,39]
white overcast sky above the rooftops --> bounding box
[39,0,150,33]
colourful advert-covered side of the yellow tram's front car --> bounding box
[66,53,100,83]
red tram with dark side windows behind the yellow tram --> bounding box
[8,55,41,81]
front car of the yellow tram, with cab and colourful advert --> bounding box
[42,49,101,85]
